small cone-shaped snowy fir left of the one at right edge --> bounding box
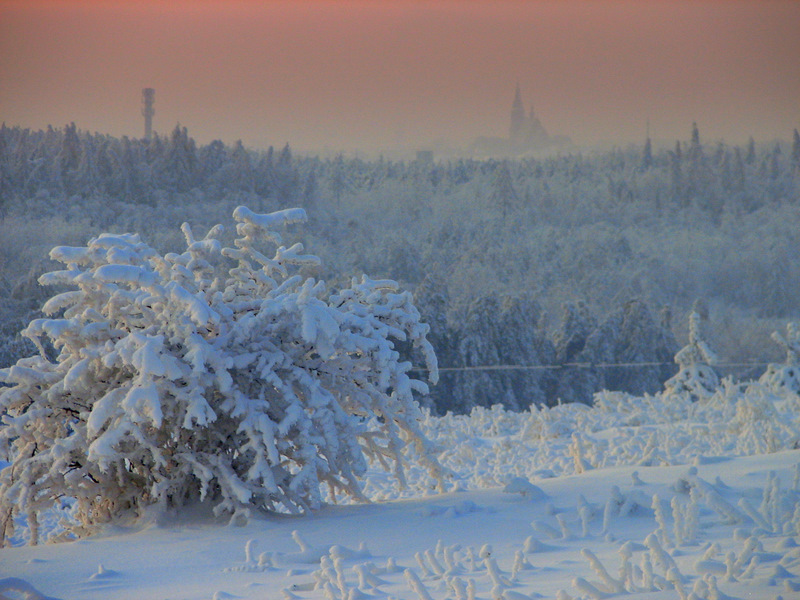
[664,311,719,400]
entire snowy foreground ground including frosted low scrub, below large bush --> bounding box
[0,386,800,600]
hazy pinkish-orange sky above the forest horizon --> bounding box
[0,0,800,150]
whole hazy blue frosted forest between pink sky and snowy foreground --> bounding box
[0,123,800,413]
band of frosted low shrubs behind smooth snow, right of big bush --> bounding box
[365,380,800,500]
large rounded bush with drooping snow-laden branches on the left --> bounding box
[0,206,440,543]
